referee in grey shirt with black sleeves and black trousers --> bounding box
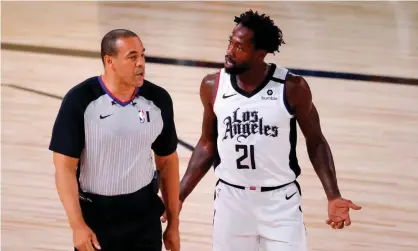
[49,29,180,251]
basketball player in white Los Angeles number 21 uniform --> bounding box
[175,10,360,251]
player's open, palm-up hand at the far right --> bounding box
[326,197,361,229]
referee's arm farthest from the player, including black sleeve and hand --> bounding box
[49,87,100,251]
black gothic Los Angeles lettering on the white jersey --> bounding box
[222,108,279,142]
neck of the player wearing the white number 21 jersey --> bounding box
[237,62,270,92]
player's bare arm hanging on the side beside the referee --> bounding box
[180,73,219,203]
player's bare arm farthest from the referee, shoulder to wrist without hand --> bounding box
[286,76,340,200]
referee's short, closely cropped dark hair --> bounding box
[100,29,139,64]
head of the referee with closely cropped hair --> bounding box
[101,29,145,87]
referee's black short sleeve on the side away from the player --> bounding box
[49,89,84,158]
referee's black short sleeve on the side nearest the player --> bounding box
[152,89,178,156]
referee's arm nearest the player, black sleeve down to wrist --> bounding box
[152,92,180,228]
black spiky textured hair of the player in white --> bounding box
[234,10,286,54]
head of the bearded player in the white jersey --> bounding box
[225,10,285,74]
